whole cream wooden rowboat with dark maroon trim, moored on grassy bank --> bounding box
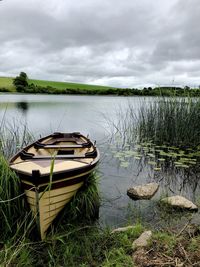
[10,133,99,239]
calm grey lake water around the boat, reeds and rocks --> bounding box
[0,94,200,230]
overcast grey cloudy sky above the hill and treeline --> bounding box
[0,0,200,87]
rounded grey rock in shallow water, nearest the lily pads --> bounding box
[127,183,159,200]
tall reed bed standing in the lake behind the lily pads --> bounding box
[107,97,200,147]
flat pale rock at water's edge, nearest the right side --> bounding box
[161,195,198,211]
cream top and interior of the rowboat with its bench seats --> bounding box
[10,134,97,175]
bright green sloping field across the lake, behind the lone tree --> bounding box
[0,77,113,92]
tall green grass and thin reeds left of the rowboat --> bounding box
[0,120,33,241]
